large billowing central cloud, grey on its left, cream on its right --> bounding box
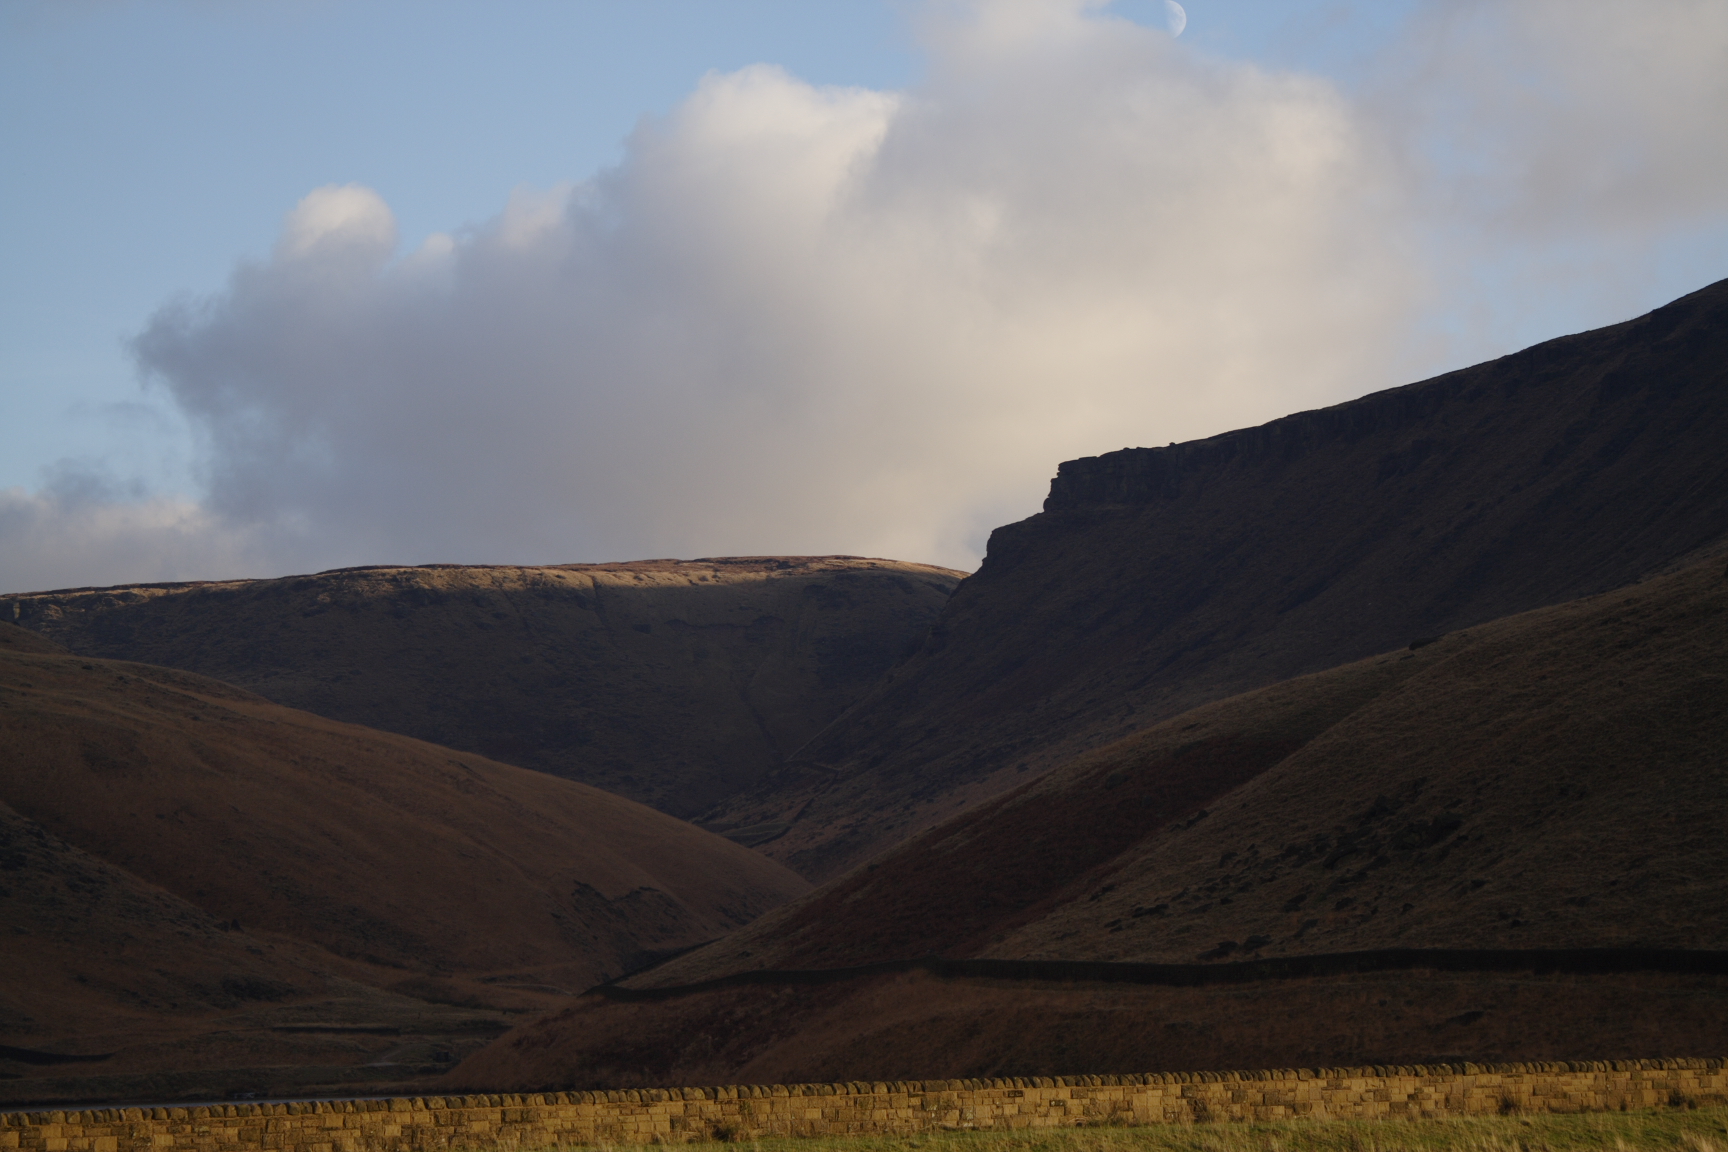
[118,5,1422,576]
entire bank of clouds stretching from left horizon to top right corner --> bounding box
[0,0,1728,589]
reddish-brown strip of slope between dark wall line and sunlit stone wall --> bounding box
[444,972,1728,1092]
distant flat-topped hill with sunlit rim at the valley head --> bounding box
[0,556,964,818]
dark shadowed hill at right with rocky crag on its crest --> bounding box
[715,282,1728,879]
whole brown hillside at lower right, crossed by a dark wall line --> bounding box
[454,560,1728,1085]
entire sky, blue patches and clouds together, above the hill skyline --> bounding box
[0,0,1728,592]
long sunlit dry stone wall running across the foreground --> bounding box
[0,1059,1728,1152]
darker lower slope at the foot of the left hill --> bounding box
[0,805,525,1104]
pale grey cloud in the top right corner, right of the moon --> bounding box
[1386,0,1728,234]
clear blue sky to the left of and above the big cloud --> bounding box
[0,0,918,487]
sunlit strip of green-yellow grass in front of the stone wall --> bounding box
[549,1107,1728,1152]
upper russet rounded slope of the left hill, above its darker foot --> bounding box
[0,625,807,986]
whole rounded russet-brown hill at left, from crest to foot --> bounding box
[0,623,809,1098]
